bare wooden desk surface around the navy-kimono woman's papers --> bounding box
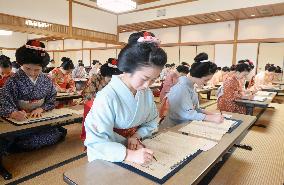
[0,105,83,135]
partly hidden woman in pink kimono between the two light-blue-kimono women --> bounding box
[160,65,189,102]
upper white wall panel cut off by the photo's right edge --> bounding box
[238,16,284,40]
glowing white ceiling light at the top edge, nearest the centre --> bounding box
[97,0,137,13]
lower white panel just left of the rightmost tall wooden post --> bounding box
[215,44,233,67]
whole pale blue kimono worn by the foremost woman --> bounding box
[85,76,158,162]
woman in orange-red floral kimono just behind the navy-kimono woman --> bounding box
[49,57,76,93]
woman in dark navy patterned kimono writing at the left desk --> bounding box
[0,40,56,121]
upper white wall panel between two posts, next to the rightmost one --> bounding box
[181,21,235,42]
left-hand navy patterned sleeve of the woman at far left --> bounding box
[0,79,18,117]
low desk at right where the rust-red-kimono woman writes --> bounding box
[235,92,276,116]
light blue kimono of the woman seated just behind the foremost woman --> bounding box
[167,76,205,123]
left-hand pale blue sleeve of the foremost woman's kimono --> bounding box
[85,95,126,162]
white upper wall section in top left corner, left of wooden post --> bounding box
[0,0,69,25]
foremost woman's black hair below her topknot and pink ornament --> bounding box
[117,42,167,73]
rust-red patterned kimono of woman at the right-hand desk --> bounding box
[217,75,246,114]
